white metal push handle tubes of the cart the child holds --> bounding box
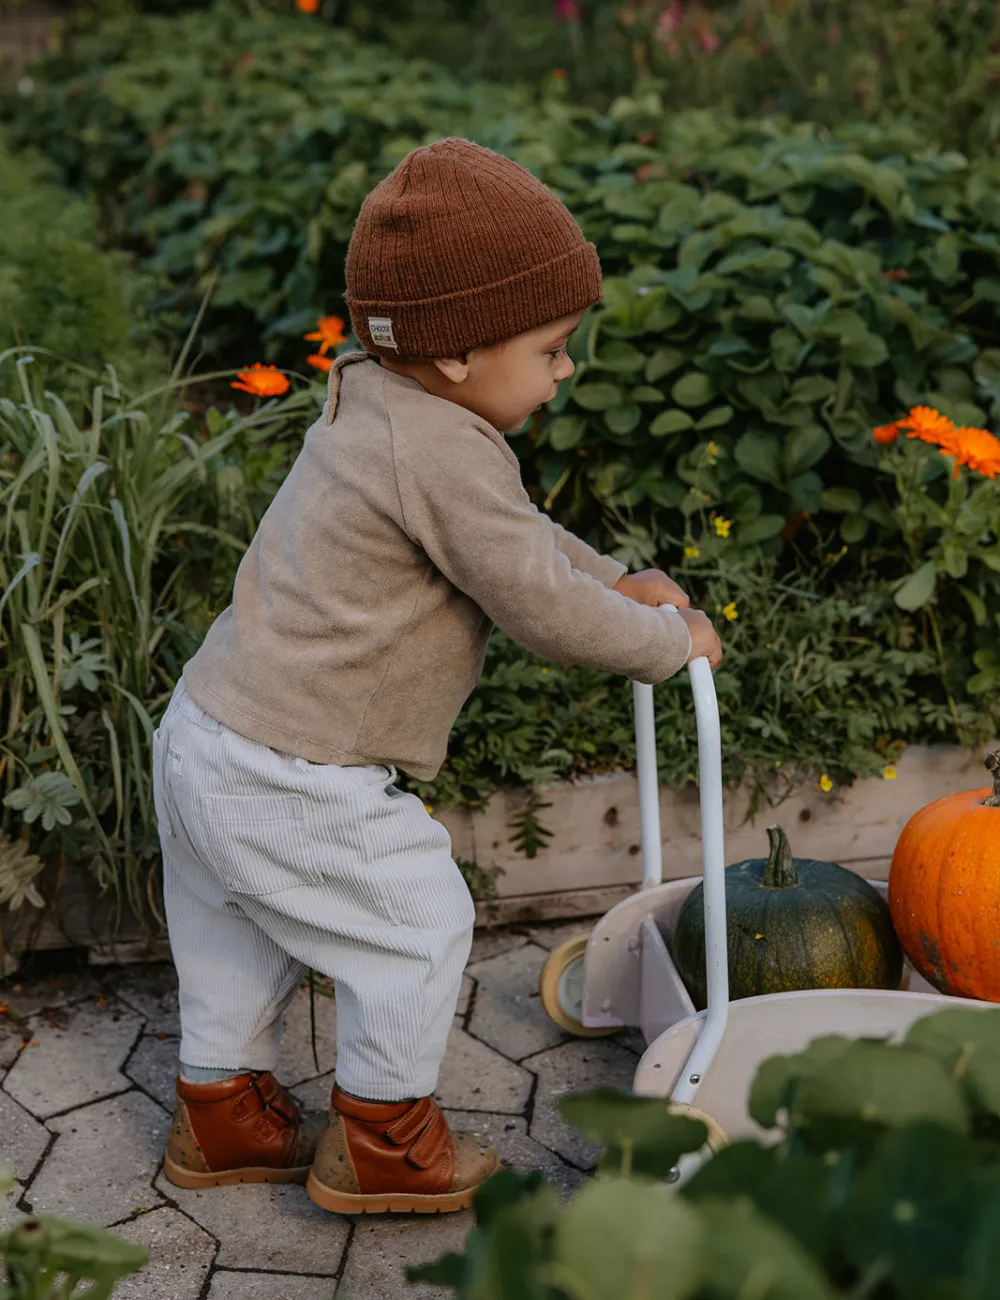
[633,608,730,1102]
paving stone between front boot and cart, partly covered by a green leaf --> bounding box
[525,1039,636,1169]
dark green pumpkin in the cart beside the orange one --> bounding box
[671,826,902,1010]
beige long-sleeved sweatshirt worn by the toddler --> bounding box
[183,354,691,779]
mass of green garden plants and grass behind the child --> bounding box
[0,3,1000,930]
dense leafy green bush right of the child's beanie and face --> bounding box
[507,107,997,579]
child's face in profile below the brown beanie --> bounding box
[382,312,583,433]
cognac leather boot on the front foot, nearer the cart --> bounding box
[306,1086,499,1214]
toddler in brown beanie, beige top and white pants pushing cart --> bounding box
[153,139,722,1213]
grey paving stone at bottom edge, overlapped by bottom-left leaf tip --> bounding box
[114,1206,216,1300]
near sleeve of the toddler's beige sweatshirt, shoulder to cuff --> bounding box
[393,405,691,683]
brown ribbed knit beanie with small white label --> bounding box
[346,139,601,360]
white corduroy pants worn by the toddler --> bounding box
[153,681,475,1101]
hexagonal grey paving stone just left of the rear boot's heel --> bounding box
[29,1091,170,1223]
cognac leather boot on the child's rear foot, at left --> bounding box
[164,1070,326,1187]
